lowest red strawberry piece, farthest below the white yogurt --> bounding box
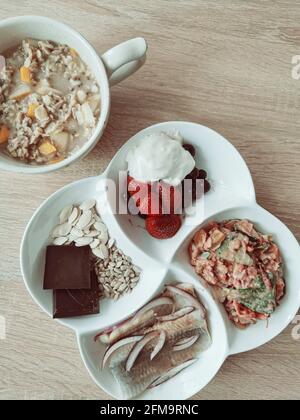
[146,214,181,239]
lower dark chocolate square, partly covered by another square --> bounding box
[53,271,100,318]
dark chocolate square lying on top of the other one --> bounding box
[44,245,91,290]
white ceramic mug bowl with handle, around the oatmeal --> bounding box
[0,16,147,173]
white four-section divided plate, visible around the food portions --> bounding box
[21,122,300,399]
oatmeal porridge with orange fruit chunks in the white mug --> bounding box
[0,39,100,164]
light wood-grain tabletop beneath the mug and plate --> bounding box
[0,0,300,399]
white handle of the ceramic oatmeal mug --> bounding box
[101,38,147,86]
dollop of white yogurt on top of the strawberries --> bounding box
[126,132,195,186]
